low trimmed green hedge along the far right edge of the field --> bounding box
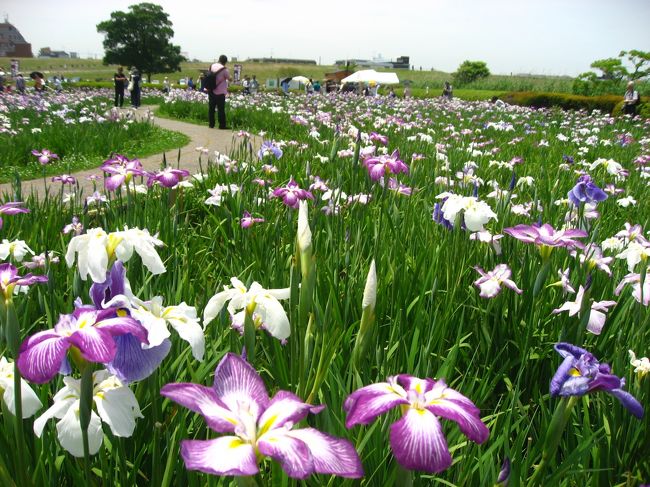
[500,91,622,113]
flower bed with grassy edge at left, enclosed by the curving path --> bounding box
[0,90,187,182]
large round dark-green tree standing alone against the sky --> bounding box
[97,3,185,81]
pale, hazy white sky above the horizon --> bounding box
[0,0,650,76]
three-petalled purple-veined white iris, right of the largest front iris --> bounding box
[343,374,490,473]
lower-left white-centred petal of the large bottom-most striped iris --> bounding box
[181,436,259,475]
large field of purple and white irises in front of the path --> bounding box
[0,91,650,487]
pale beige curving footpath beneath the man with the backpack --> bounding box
[0,106,259,200]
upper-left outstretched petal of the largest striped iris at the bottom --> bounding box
[160,383,239,433]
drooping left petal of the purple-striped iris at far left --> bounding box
[18,330,70,384]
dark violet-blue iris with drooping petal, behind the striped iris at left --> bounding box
[90,260,171,384]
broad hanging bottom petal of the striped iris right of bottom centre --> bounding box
[390,409,451,473]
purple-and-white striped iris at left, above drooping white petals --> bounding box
[18,307,147,384]
